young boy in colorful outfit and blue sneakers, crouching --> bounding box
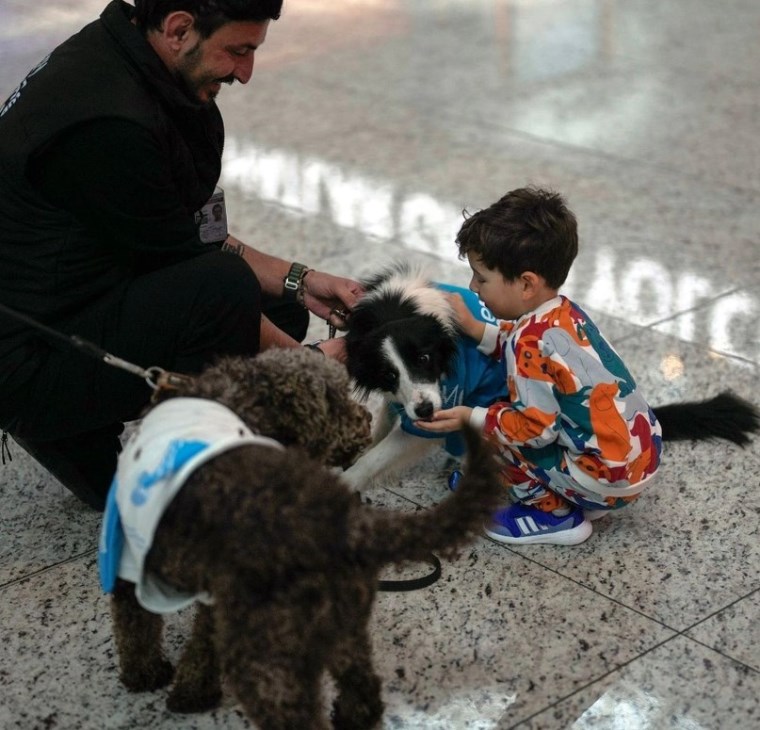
[415,188,662,545]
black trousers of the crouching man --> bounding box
[2,252,309,510]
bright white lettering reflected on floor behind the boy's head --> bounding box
[222,138,760,361]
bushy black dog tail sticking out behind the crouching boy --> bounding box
[653,391,760,446]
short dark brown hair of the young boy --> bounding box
[456,187,578,289]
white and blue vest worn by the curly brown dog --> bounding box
[98,398,284,613]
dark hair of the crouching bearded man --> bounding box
[135,0,282,39]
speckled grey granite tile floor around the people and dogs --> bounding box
[0,0,760,730]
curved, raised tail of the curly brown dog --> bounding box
[351,427,507,566]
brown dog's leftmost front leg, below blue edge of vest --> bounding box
[111,578,174,692]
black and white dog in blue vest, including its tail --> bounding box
[344,265,760,488]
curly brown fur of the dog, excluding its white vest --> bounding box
[113,351,502,730]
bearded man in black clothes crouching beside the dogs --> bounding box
[0,0,361,509]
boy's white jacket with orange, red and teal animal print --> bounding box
[472,296,662,496]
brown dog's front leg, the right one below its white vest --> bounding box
[166,604,222,712]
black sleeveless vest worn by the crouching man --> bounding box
[0,0,224,385]
